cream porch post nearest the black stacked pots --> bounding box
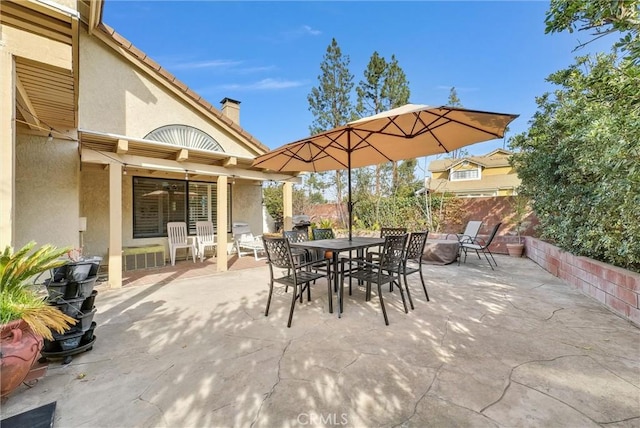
[109,163,122,288]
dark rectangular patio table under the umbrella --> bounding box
[289,236,384,318]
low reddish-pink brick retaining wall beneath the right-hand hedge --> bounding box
[525,236,640,326]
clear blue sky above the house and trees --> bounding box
[103,0,616,158]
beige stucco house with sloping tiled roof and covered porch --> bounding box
[0,0,298,287]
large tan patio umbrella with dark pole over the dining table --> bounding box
[253,104,518,239]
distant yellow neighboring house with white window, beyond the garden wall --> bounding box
[426,149,520,197]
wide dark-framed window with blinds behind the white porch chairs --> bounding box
[133,177,231,238]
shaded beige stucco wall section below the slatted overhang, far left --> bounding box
[14,134,80,248]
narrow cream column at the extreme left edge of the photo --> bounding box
[0,50,16,251]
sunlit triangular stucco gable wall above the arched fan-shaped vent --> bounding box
[79,32,251,156]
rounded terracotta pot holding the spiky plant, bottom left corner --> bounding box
[0,320,43,397]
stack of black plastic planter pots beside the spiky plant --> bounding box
[40,259,100,364]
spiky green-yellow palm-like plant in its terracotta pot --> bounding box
[0,242,76,397]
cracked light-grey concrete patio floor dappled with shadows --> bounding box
[2,256,640,427]
